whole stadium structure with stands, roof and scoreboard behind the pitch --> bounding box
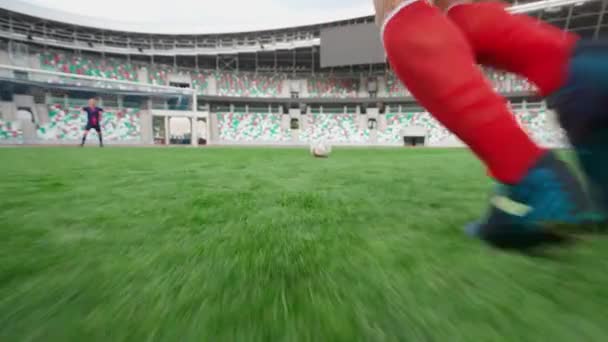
[0,0,608,146]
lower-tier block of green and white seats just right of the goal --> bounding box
[217,113,291,143]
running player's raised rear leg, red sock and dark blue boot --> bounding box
[448,2,608,211]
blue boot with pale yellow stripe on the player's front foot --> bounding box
[466,152,604,250]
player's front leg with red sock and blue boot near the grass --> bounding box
[382,1,586,247]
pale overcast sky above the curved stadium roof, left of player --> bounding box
[13,0,373,33]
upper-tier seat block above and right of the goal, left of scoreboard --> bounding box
[216,72,284,97]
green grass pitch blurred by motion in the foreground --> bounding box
[0,148,608,342]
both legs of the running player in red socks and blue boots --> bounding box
[374,0,608,249]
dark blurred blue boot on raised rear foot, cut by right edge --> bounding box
[548,41,608,213]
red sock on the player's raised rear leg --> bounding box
[448,2,578,95]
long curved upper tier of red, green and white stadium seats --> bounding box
[0,44,533,99]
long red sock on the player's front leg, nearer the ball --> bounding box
[383,1,543,184]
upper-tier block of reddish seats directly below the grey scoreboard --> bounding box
[307,75,359,99]
